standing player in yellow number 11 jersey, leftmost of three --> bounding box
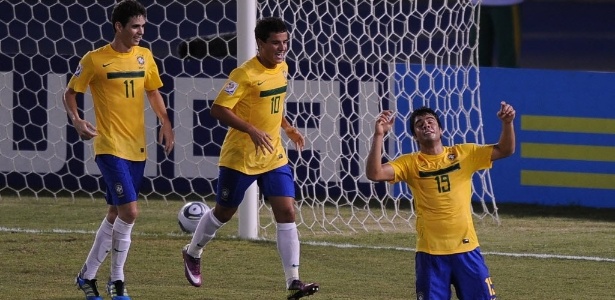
[64,0,174,300]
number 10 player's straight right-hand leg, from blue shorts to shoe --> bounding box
[258,165,319,299]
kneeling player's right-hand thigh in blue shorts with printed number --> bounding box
[452,248,496,300]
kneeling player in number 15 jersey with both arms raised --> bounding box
[366,102,515,300]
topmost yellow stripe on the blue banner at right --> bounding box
[521,115,615,134]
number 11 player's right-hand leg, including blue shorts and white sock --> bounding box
[96,155,145,300]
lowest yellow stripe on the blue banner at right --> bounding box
[521,170,615,190]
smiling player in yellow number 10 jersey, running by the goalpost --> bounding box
[182,17,319,299]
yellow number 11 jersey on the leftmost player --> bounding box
[68,44,162,161]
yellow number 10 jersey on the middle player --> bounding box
[214,57,288,175]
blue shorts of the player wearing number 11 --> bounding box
[95,154,145,206]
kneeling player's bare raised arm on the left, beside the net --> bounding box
[365,110,395,181]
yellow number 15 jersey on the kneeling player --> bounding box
[389,144,493,255]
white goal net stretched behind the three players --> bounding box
[0,0,498,235]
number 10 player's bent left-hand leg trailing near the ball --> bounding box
[182,167,256,287]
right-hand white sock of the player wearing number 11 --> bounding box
[109,217,134,281]
